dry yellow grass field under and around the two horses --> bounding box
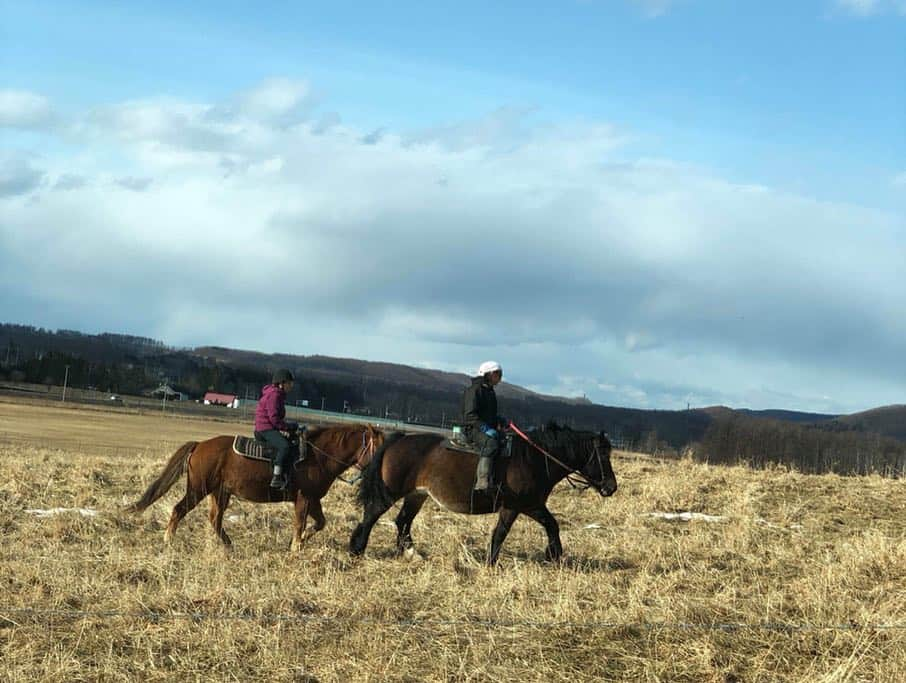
[0,400,906,683]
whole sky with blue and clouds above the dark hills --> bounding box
[0,0,906,411]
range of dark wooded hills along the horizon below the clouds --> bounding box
[0,324,906,450]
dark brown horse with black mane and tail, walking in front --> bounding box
[349,425,617,565]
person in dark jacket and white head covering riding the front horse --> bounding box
[462,361,507,491]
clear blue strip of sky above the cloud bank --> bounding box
[0,0,906,187]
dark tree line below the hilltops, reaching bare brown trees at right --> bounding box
[0,325,906,476]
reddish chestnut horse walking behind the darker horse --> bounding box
[127,425,384,550]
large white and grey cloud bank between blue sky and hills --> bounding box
[0,81,906,409]
